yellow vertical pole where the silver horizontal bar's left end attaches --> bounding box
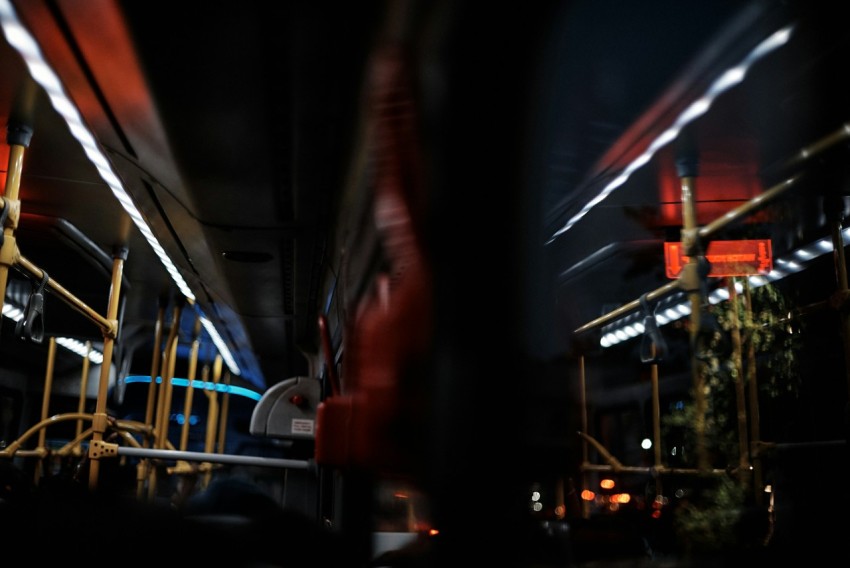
[89,248,128,489]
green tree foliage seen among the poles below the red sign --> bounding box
[662,284,802,547]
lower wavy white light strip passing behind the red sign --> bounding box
[599,233,832,348]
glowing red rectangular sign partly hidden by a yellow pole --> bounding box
[664,239,773,278]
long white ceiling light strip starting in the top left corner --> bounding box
[0,0,240,375]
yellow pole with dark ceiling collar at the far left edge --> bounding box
[0,126,32,316]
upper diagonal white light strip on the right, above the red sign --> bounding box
[546,26,793,245]
